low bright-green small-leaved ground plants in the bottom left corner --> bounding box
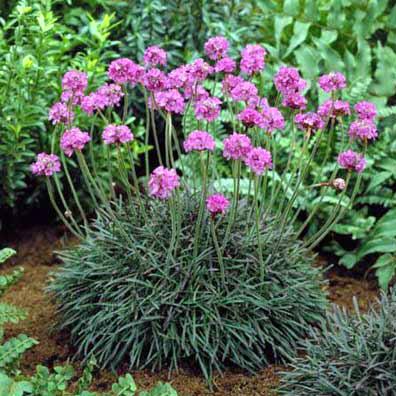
[0,248,177,396]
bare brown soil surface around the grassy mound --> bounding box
[1,227,378,396]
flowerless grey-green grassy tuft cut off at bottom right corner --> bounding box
[281,290,396,396]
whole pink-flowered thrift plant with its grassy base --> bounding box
[32,37,377,379]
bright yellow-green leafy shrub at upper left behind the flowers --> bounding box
[0,0,114,217]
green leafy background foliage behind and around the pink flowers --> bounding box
[0,0,396,287]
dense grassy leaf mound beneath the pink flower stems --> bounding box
[51,196,326,378]
